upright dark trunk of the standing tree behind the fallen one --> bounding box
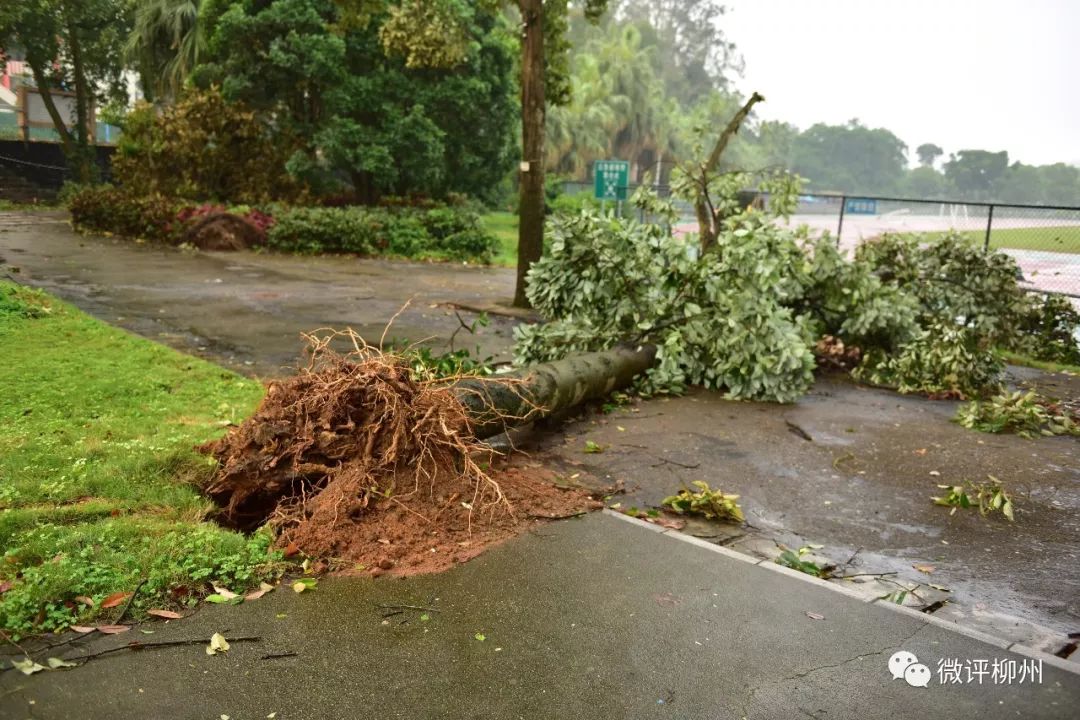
[514,0,545,308]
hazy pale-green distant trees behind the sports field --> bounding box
[548,0,1080,205]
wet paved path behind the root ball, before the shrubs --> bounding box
[0,213,514,377]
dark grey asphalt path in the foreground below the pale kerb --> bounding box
[0,514,1080,720]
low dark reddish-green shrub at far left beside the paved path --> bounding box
[68,186,177,240]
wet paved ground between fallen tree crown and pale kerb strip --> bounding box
[529,377,1080,652]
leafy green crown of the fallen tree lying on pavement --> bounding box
[515,184,1076,403]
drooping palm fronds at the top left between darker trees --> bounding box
[124,0,206,100]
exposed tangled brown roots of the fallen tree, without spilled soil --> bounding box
[201,331,511,551]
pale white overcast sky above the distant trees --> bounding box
[721,0,1080,165]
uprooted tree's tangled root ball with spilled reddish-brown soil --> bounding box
[200,336,589,572]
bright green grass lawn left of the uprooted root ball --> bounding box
[0,282,279,637]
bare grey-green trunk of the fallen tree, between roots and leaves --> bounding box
[451,345,657,439]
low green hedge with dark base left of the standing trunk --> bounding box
[267,206,498,263]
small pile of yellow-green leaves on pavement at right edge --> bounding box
[956,391,1080,438]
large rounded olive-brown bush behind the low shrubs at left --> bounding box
[112,87,300,203]
